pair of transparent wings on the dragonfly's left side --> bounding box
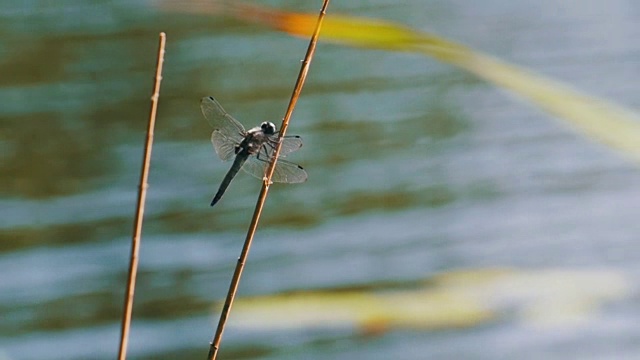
[200,96,246,160]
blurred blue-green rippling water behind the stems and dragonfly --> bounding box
[0,0,640,360]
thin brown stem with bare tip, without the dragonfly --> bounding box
[118,32,167,360]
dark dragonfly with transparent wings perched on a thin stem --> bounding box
[200,96,307,206]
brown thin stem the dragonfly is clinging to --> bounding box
[208,0,329,360]
